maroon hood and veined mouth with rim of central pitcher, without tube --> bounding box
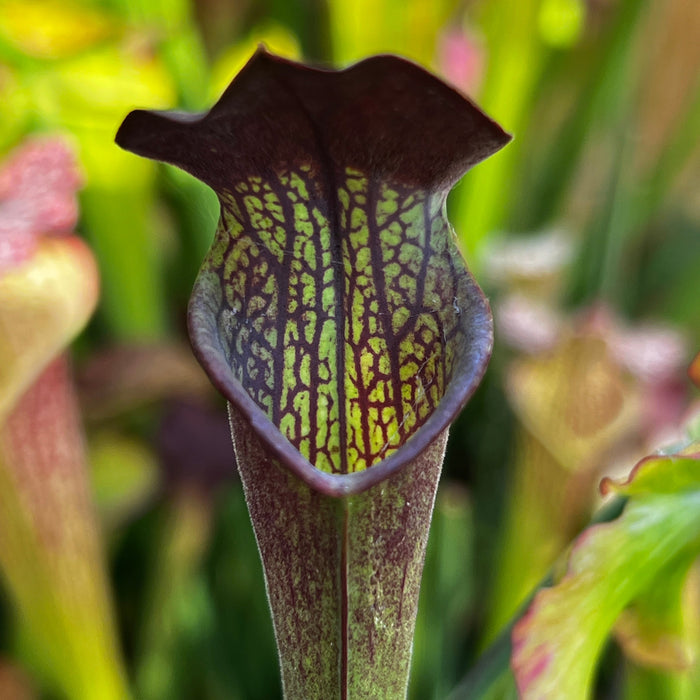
[117,51,510,494]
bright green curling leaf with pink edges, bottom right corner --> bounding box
[512,448,700,700]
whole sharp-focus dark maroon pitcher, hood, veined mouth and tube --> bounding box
[117,50,509,700]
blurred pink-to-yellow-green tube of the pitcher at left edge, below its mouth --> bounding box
[0,358,129,700]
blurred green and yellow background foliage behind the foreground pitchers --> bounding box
[0,0,700,700]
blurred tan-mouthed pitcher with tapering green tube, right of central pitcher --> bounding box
[488,329,639,636]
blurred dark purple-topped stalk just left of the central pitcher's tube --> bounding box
[135,400,235,700]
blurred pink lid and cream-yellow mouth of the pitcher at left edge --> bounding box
[0,139,98,423]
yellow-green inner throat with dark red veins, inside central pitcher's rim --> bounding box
[203,161,467,473]
